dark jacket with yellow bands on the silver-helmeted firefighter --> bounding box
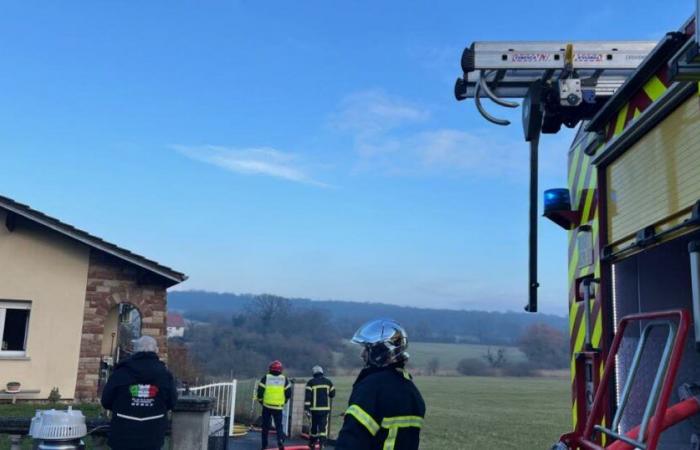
[335,365,425,450]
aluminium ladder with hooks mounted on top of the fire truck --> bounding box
[455,41,657,128]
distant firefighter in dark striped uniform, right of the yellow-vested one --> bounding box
[304,366,335,449]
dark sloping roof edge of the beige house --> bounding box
[0,195,187,285]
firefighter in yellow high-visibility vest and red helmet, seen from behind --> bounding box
[257,361,292,450]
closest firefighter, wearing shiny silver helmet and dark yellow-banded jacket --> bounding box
[335,319,425,450]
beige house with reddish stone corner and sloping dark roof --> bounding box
[0,196,187,400]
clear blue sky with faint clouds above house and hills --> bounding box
[0,0,694,314]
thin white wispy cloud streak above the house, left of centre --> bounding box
[173,145,330,187]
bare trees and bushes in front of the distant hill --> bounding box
[169,295,568,383]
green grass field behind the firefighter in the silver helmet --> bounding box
[331,377,571,450]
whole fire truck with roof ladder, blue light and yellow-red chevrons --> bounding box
[455,1,700,450]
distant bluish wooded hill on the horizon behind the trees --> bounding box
[168,291,568,345]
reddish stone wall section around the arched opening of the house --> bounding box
[75,249,167,400]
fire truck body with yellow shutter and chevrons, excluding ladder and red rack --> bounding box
[565,15,700,450]
